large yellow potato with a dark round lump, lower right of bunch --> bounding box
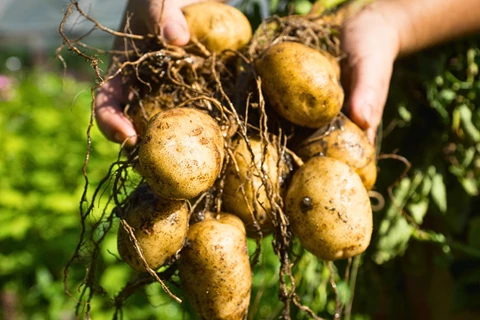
[285,157,373,260]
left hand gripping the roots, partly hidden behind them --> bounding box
[95,0,210,146]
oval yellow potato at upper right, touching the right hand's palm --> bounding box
[255,42,344,128]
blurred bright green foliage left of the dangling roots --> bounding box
[0,72,116,319]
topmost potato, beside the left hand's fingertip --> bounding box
[182,2,252,53]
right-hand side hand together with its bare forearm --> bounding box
[342,0,480,142]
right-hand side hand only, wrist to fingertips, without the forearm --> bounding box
[341,5,400,143]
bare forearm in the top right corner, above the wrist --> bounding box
[373,0,480,55]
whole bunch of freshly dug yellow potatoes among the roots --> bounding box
[118,2,376,319]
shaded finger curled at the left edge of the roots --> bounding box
[95,78,137,146]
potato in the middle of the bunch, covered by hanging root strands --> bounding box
[223,137,282,234]
